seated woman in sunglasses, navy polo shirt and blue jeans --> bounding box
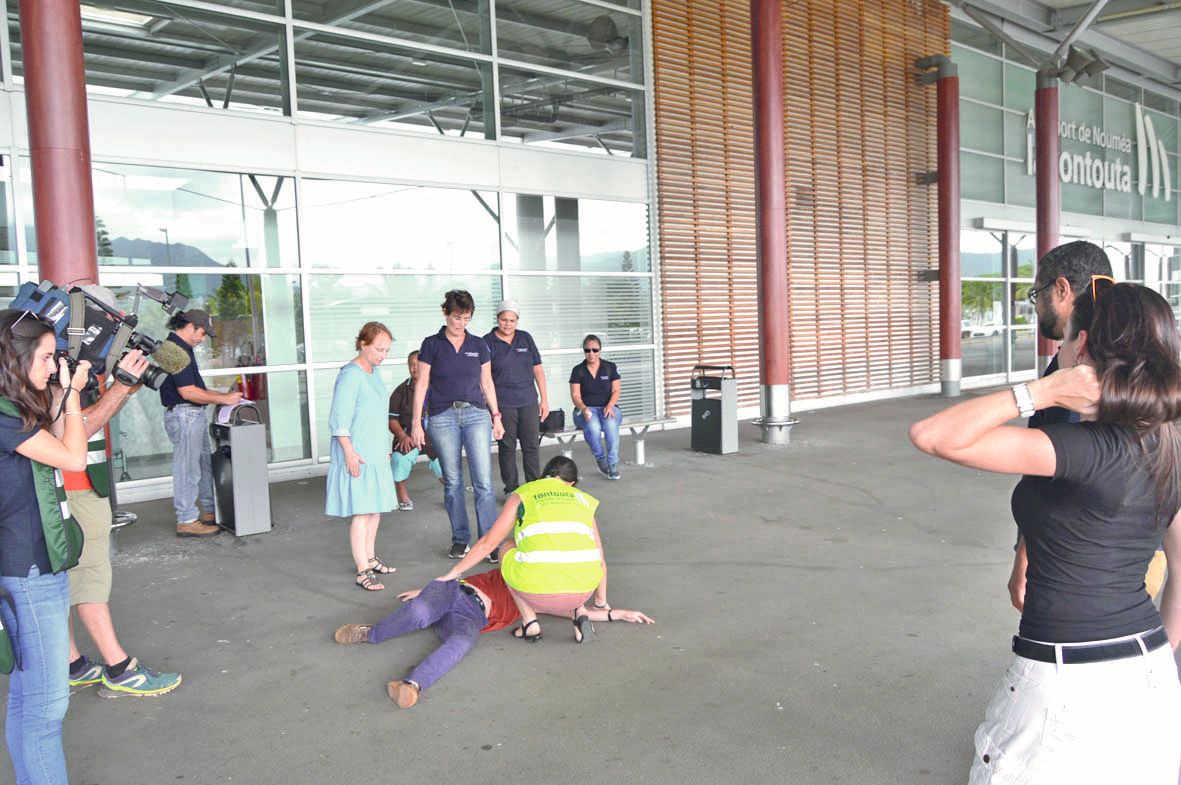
[570,335,624,479]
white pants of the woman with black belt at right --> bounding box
[968,645,1181,785]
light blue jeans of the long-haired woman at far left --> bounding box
[0,564,70,785]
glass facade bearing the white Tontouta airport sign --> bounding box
[952,20,1181,384]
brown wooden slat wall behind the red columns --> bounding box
[652,0,948,414]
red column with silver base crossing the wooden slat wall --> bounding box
[750,0,794,444]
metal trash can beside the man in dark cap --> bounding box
[209,401,270,537]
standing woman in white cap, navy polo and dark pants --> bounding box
[484,300,549,496]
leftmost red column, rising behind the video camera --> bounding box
[20,0,98,286]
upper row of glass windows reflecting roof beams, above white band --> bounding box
[6,0,647,158]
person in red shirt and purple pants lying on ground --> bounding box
[334,569,654,708]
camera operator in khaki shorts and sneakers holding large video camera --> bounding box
[63,339,181,698]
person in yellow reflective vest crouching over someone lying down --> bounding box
[437,456,607,643]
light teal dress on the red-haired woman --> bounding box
[324,362,398,518]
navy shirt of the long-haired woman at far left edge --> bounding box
[0,414,53,578]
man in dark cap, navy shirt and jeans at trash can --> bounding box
[159,308,242,537]
